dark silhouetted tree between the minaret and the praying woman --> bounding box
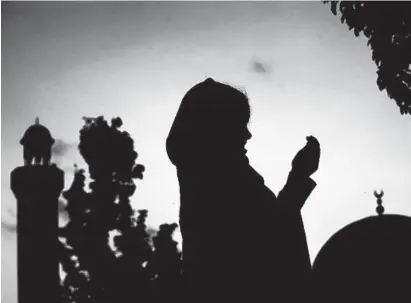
[60,117,180,303]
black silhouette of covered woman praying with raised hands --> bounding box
[167,78,320,303]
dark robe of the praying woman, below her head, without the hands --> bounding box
[172,161,315,303]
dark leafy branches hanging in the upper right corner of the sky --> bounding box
[323,1,411,115]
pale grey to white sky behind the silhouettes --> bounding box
[1,2,411,303]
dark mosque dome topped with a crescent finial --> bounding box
[313,193,411,302]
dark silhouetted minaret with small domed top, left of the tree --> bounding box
[10,118,64,303]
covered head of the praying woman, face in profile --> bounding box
[167,78,251,165]
